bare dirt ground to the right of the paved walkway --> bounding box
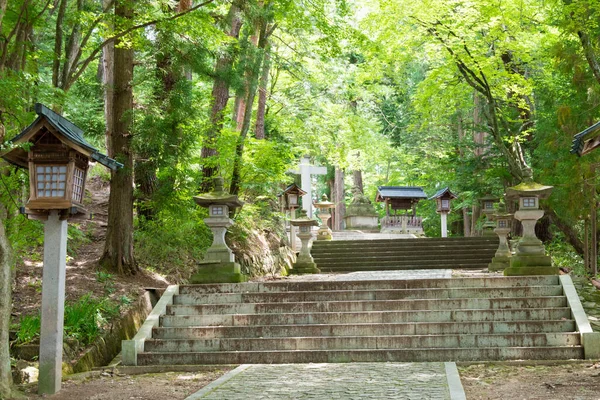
[458,362,600,400]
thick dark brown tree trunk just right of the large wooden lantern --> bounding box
[100,0,138,274]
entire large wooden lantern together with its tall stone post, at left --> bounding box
[0,103,123,394]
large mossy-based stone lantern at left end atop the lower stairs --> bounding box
[190,177,247,283]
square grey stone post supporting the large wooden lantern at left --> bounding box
[38,210,67,394]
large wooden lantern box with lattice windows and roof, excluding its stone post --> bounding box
[1,103,123,219]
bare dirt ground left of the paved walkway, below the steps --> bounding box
[15,369,228,400]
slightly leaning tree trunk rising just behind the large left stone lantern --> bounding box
[200,1,242,192]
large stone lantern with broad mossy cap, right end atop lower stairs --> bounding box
[504,181,558,275]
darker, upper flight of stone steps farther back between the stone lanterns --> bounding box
[311,237,498,272]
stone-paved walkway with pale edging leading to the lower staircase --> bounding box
[186,362,466,400]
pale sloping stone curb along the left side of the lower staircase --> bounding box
[121,285,179,366]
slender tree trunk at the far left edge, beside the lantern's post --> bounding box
[0,184,13,399]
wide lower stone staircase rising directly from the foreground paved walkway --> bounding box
[123,276,591,365]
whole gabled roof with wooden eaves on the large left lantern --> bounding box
[0,103,123,170]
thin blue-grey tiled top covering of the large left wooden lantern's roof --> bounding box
[11,103,123,170]
